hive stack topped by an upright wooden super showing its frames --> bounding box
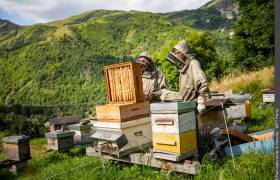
[92,62,152,157]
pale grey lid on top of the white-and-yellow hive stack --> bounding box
[150,101,196,113]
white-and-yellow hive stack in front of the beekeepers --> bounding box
[151,102,197,161]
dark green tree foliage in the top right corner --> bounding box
[232,0,274,69]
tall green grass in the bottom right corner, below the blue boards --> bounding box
[195,154,276,180]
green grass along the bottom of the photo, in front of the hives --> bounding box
[0,138,275,180]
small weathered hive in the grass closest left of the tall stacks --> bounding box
[69,123,93,144]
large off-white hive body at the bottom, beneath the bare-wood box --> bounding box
[92,117,152,156]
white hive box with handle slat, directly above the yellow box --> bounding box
[151,111,196,134]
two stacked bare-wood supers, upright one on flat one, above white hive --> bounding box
[96,62,150,122]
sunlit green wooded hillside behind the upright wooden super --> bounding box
[0,10,196,109]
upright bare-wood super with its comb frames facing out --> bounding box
[104,62,145,103]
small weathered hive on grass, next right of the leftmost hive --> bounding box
[45,130,75,151]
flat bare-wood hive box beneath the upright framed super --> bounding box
[96,101,150,122]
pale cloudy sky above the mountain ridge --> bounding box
[0,0,210,25]
